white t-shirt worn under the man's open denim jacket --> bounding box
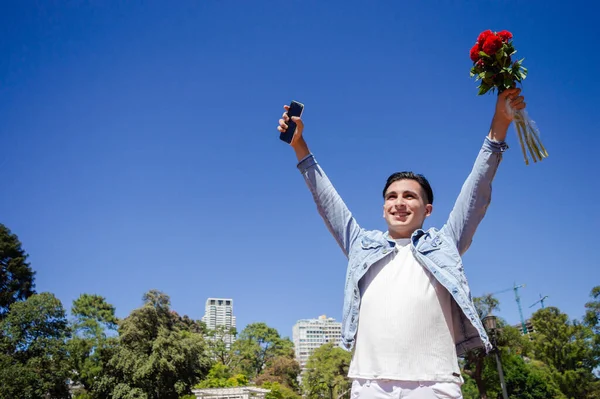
[348,239,462,382]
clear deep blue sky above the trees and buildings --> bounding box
[0,0,600,336]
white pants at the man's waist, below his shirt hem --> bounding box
[350,379,462,399]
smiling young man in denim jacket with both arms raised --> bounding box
[278,89,525,399]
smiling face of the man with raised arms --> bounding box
[383,179,433,239]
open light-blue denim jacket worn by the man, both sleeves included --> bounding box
[298,137,508,356]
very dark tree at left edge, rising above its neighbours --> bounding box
[0,223,35,320]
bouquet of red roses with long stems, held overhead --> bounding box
[470,30,548,165]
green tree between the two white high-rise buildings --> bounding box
[232,323,294,379]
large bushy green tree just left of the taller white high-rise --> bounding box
[98,290,210,399]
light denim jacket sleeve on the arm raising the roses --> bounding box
[442,137,508,255]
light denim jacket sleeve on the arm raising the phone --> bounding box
[298,154,360,257]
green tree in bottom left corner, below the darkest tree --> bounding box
[0,293,70,399]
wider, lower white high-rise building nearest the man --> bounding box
[293,315,342,371]
